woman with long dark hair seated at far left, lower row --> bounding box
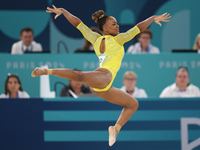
[0,75,30,98]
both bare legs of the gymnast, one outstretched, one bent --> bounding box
[32,68,138,146]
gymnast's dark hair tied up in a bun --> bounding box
[92,10,110,31]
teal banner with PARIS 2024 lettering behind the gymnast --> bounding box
[0,53,200,97]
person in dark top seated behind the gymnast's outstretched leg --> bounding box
[60,69,91,97]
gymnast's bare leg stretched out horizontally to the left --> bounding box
[32,68,112,89]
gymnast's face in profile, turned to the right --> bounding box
[103,17,119,36]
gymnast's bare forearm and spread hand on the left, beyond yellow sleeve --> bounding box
[46,5,81,27]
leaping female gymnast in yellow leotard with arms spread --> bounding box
[32,5,171,146]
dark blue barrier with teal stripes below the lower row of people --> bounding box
[0,98,200,150]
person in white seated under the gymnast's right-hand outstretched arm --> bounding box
[127,29,160,54]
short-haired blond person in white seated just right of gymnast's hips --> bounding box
[121,71,147,98]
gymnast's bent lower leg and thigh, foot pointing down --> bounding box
[97,87,139,146]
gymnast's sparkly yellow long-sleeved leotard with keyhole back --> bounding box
[77,22,140,92]
